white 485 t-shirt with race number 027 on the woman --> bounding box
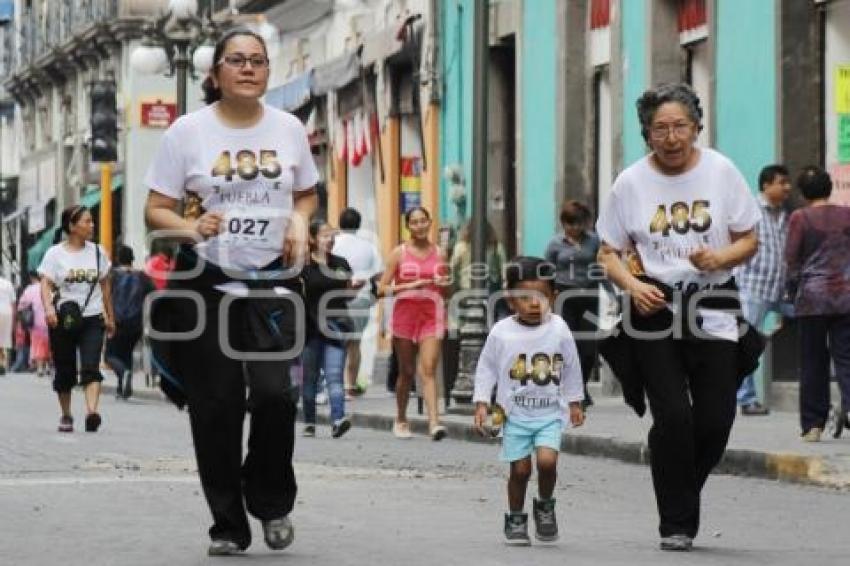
[145,104,319,270]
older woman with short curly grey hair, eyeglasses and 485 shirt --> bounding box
[596,84,761,551]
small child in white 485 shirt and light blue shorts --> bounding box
[472,257,584,545]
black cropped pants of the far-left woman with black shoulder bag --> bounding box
[48,314,104,393]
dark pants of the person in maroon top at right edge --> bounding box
[797,314,850,433]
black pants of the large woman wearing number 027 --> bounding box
[173,292,297,547]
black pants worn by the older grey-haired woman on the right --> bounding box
[635,326,738,537]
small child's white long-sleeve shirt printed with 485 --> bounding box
[472,314,584,421]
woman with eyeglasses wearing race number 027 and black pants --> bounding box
[145,29,319,556]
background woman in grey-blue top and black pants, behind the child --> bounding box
[543,200,599,408]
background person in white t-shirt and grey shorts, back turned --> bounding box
[333,208,383,399]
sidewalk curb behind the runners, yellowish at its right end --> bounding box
[114,384,850,489]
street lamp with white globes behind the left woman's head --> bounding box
[130,0,220,116]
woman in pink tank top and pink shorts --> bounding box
[379,207,450,440]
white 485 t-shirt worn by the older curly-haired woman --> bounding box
[596,148,761,341]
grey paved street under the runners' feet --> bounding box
[0,375,850,566]
